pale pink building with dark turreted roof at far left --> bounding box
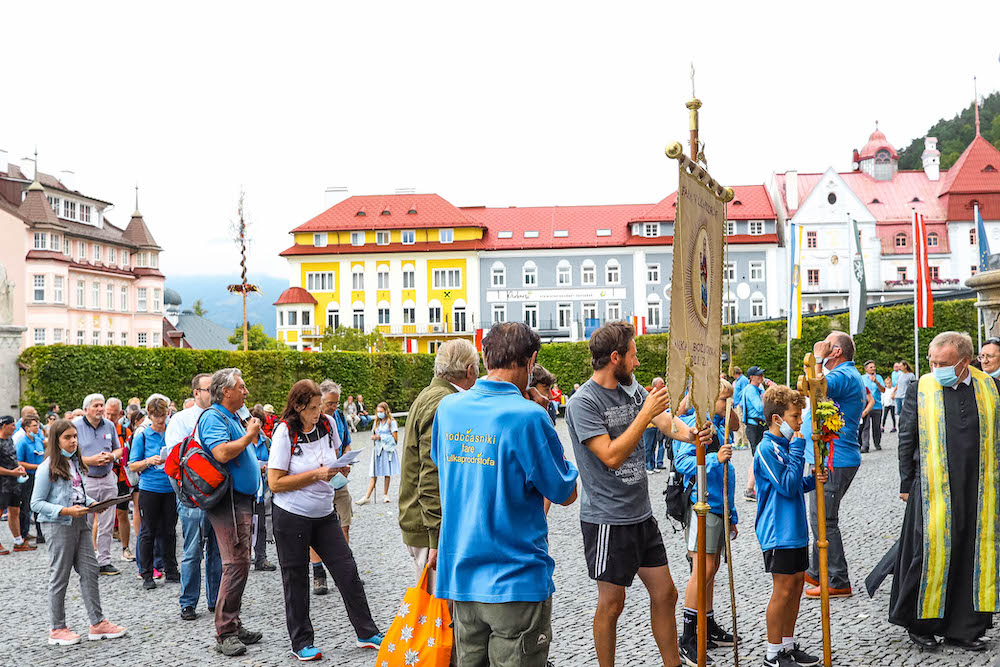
[0,150,164,347]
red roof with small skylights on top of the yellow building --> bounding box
[292,194,480,233]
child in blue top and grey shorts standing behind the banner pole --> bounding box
[674,380,740,667]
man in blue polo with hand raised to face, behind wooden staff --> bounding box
[805,331,867,598]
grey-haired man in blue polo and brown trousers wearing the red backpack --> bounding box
[198,368,263,656]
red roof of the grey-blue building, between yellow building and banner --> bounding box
[462,204,651,250]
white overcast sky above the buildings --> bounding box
[0,0,1000,279]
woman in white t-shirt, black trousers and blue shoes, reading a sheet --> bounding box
[267,380,382,661]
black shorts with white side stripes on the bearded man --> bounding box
[580,517,667,586]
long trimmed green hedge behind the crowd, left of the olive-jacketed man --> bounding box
[20,345,434,412]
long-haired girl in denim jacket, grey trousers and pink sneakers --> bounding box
[31,419,126,646]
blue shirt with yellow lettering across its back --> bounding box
[431,380,578,603]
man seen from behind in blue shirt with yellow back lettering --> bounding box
[431,322,580,667]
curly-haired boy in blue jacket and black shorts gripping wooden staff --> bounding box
[753,385,826,667]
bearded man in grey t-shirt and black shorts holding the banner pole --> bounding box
[566,322,711,665]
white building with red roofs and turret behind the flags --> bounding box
[769,129,1000,311]
